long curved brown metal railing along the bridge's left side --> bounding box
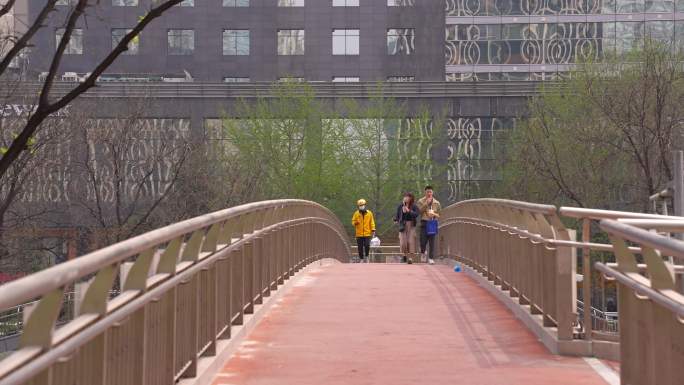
[0,200,349,385]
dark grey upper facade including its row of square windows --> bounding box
[25,0,444,82]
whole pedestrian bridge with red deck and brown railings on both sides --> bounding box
[0,199,684,385]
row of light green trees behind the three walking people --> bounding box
[215,82,438,235]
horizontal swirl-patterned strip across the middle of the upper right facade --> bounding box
[445,21,684,66]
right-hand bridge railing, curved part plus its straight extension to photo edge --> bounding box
[439,199,684,352]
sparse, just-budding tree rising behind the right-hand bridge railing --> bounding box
[499,41,684,210]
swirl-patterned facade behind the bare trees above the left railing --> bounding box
[0,118,190,204]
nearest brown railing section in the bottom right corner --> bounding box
[596,218,684,384]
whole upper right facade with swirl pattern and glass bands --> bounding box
[445,0,684,81]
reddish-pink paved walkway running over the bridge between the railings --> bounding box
[214,264,605,385]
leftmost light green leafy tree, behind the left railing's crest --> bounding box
[224,82,327,200]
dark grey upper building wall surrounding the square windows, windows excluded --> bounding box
[29,0,445,81]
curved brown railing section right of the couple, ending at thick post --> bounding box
[439,199,577,340]
